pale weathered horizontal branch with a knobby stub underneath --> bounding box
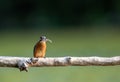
[0,56,120,71]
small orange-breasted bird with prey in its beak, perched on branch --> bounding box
[33,36,52,58]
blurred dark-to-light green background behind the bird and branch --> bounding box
[0,0,120,82]
